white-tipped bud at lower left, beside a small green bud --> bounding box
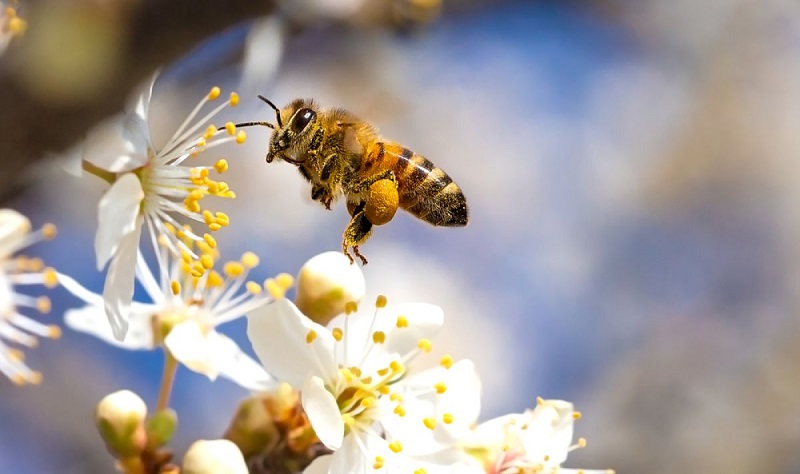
[95,390,147,459]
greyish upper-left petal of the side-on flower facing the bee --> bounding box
[83,114,150,173]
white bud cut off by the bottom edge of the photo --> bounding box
[182,439,248,474]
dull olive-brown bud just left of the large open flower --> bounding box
[225,395,280,457]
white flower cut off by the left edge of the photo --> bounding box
[0,209,61,385]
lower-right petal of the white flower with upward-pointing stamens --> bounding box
[208,331,277,392]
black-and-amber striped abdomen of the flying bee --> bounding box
[365,142,468,227]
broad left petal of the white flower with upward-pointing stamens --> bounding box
[64,305,153,350]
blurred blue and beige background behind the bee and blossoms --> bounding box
[6,0,800,473]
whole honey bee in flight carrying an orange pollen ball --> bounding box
[237,96,468,264]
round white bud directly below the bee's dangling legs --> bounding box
[295,252,366,325]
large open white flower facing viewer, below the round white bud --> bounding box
[248,297,480,474]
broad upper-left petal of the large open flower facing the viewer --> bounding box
[247,299,338,388]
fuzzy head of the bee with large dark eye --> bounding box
[264,99,317,164]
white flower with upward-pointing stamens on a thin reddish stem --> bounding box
[58,235,291,390]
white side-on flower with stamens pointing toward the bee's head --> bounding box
[83,72,245,340]
